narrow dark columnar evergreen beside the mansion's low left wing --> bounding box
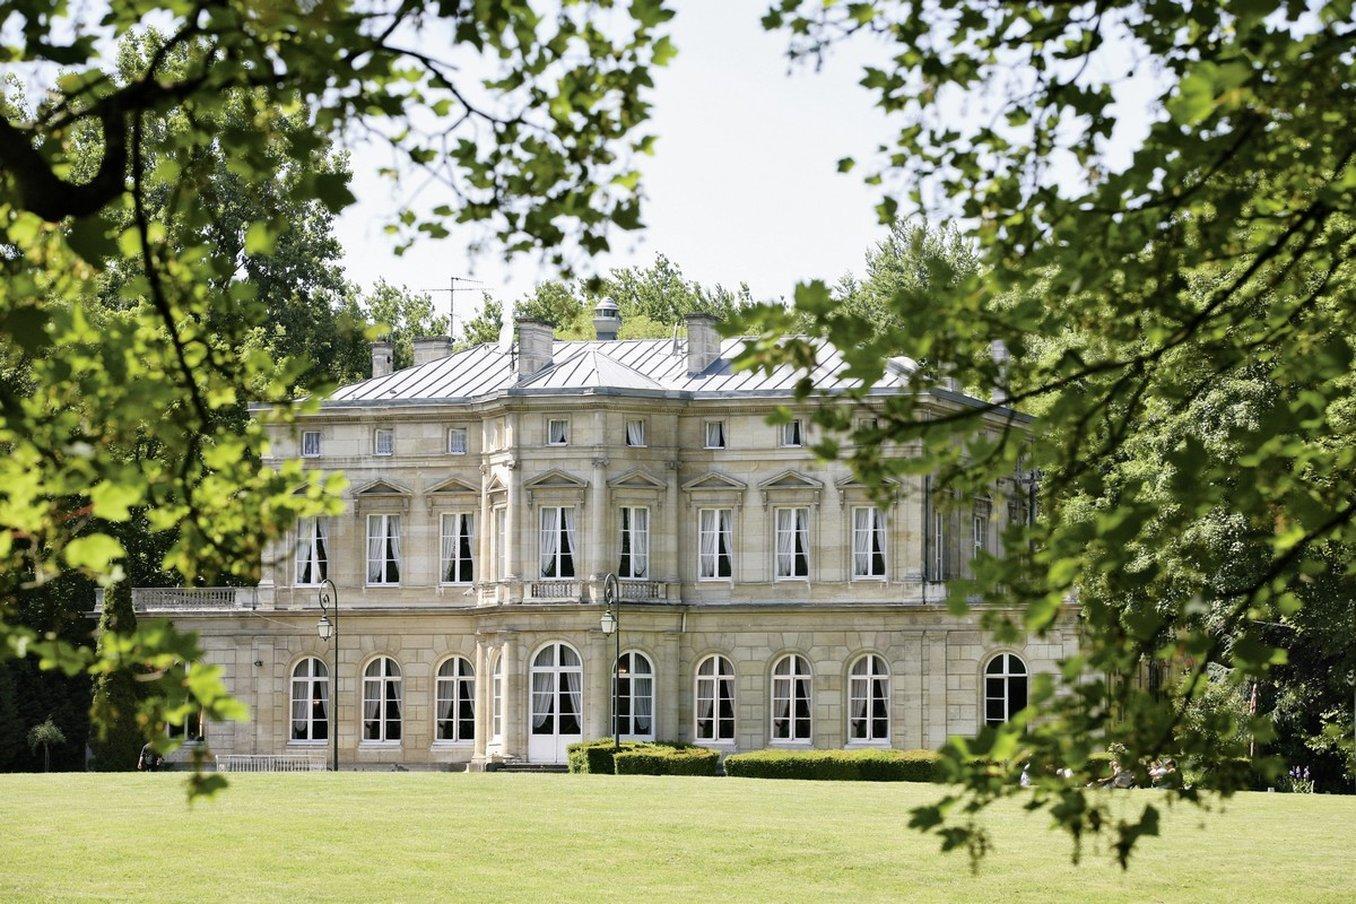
[89,580,145,773]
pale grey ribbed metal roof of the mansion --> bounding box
[324,337,914,405]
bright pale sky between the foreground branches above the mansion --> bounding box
[339,0,888,336]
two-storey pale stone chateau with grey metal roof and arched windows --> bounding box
[136,302,1077,768]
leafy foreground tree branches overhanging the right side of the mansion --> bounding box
[734,0,1356,865]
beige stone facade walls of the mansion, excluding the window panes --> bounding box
[153,323,1057,767]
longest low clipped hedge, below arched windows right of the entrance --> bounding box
[725,749,941,782]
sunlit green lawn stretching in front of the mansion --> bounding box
[0,773,1356,904]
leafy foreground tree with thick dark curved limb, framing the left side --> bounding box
[0,0,673,793]
